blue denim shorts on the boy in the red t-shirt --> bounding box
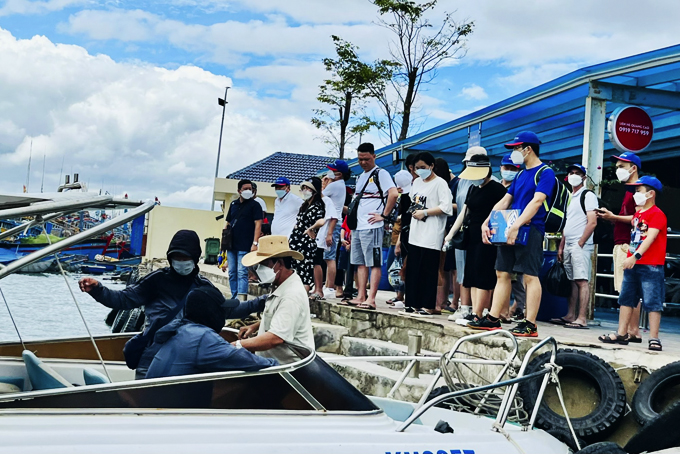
[619,265,666,312]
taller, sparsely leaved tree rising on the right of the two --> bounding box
[371,0,474,140]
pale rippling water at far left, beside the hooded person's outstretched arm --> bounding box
[0,273,125,342]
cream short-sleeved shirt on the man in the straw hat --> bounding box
[258,273,314,363]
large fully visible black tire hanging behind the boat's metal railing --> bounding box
[519,348,626,441]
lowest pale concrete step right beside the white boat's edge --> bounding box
[319,353,436,402]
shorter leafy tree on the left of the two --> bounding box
[311,35,392,159]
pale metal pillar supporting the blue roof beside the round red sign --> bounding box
[582,96,607,320]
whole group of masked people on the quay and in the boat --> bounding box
[73,127,667,379]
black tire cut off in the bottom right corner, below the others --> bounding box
[624,400,680,454]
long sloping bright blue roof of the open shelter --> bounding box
[349,45,680,173]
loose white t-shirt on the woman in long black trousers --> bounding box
[408,177,453,250]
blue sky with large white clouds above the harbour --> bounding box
[0,0,680,209]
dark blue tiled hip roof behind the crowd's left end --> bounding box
[227,151,335,184]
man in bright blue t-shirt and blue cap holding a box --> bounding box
[468,131,555,337]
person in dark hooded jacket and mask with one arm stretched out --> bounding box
[79,230,214,379]
